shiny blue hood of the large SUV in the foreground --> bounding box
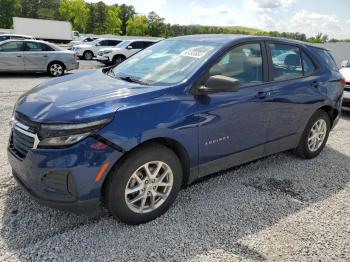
[15,70,165,123]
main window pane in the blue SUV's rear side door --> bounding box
[269,44,303,81]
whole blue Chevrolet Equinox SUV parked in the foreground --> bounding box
[8,35,345,224]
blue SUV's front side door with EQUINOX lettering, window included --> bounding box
[198,43,270,176]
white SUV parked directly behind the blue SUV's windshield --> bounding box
[96,39,159,65]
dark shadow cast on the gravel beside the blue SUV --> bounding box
[0,146,350,261]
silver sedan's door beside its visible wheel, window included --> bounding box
[23,41,50,71]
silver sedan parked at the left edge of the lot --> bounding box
[0,40,79,77]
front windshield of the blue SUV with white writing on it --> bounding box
[113,40,217,85]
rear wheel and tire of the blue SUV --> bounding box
[294,110,331,159]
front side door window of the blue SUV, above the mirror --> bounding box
[209,43,263,86]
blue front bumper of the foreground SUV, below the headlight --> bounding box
[8,137,122,215]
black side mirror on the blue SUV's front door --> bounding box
[198,75,240,94]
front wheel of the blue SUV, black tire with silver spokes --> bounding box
[105,143,183,225]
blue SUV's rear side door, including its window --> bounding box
[264,42,321,153]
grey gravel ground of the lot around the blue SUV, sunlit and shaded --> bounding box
[0,62,350,261]
